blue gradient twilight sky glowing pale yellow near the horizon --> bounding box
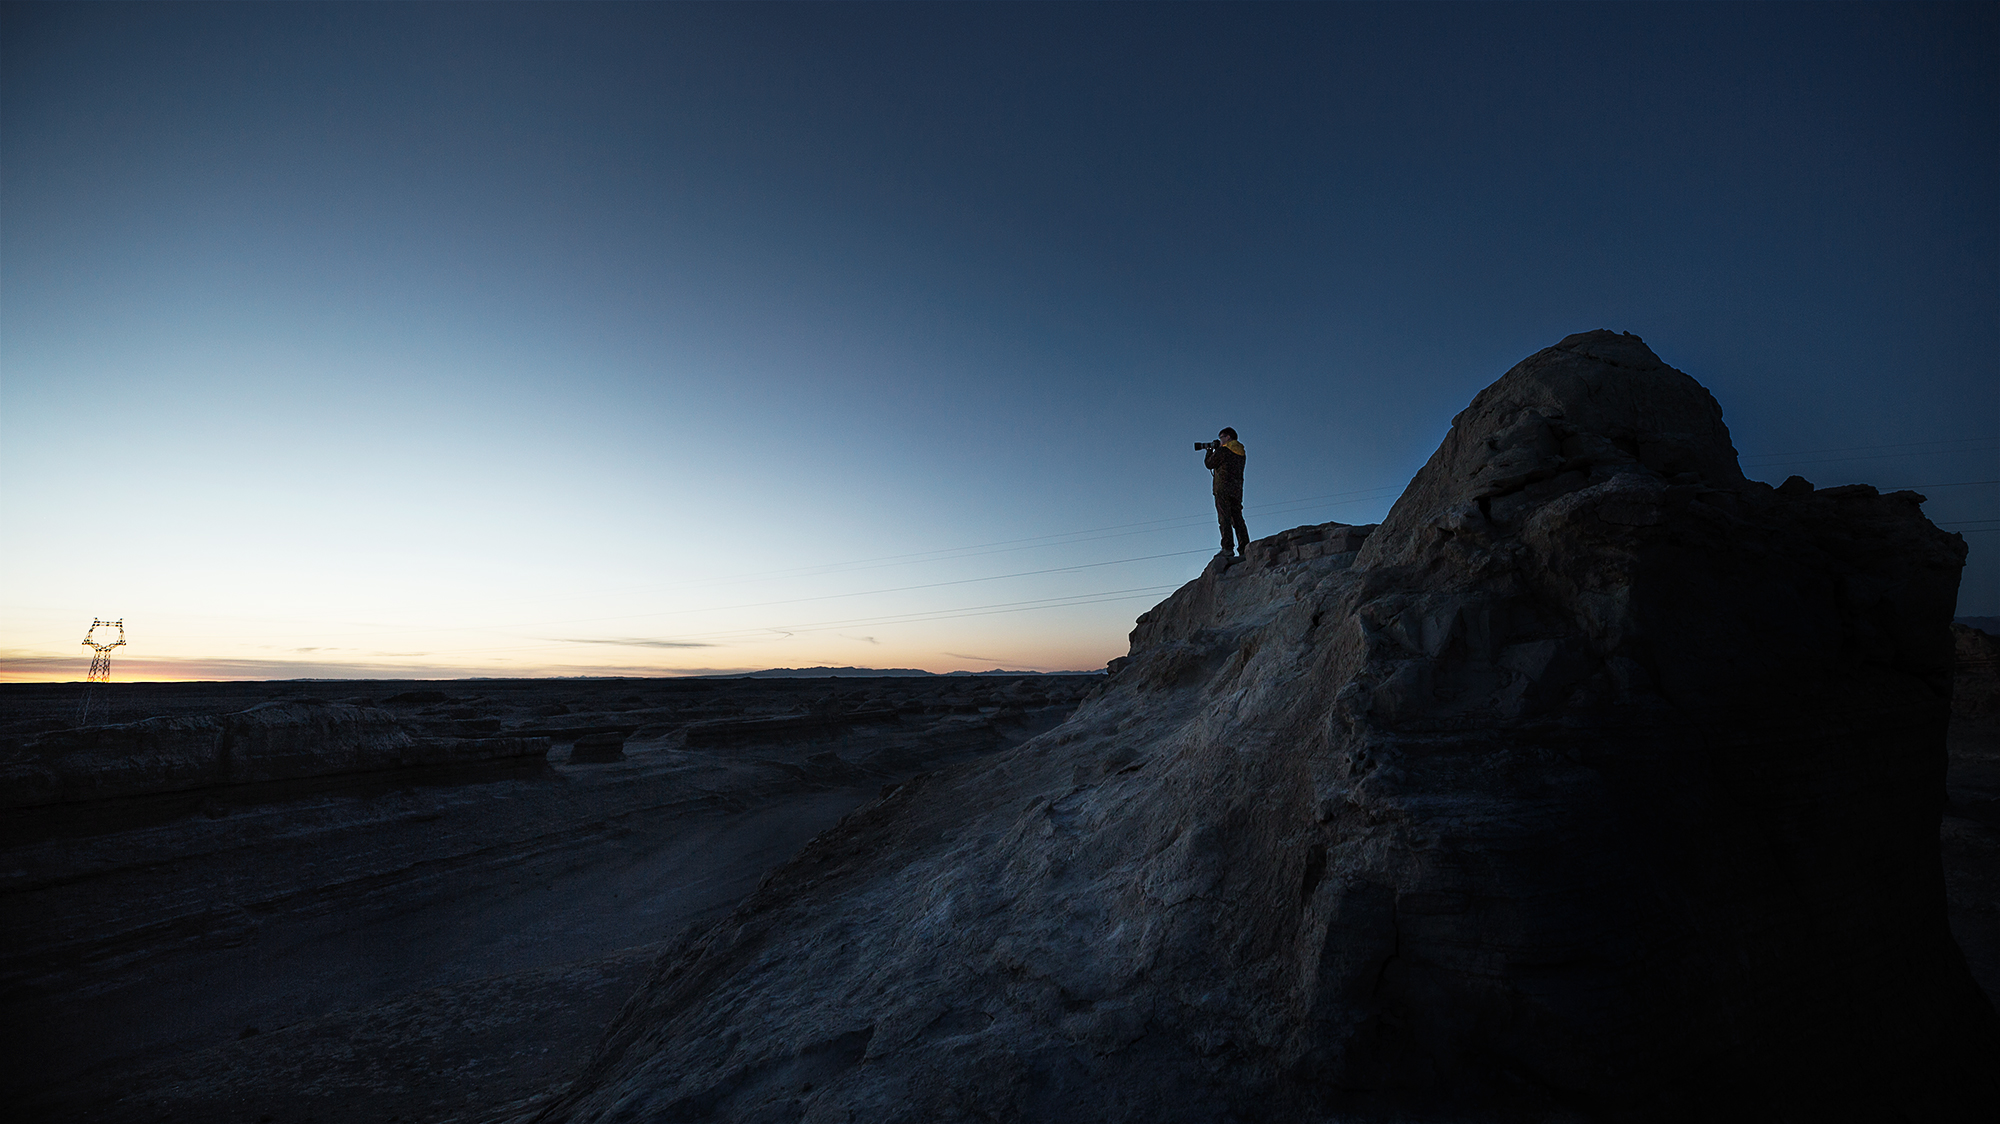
[0,4,2000,678]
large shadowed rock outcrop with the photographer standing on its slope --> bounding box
[544,332,2000,1122]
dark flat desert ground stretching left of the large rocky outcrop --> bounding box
[0,678,1094,1120]
